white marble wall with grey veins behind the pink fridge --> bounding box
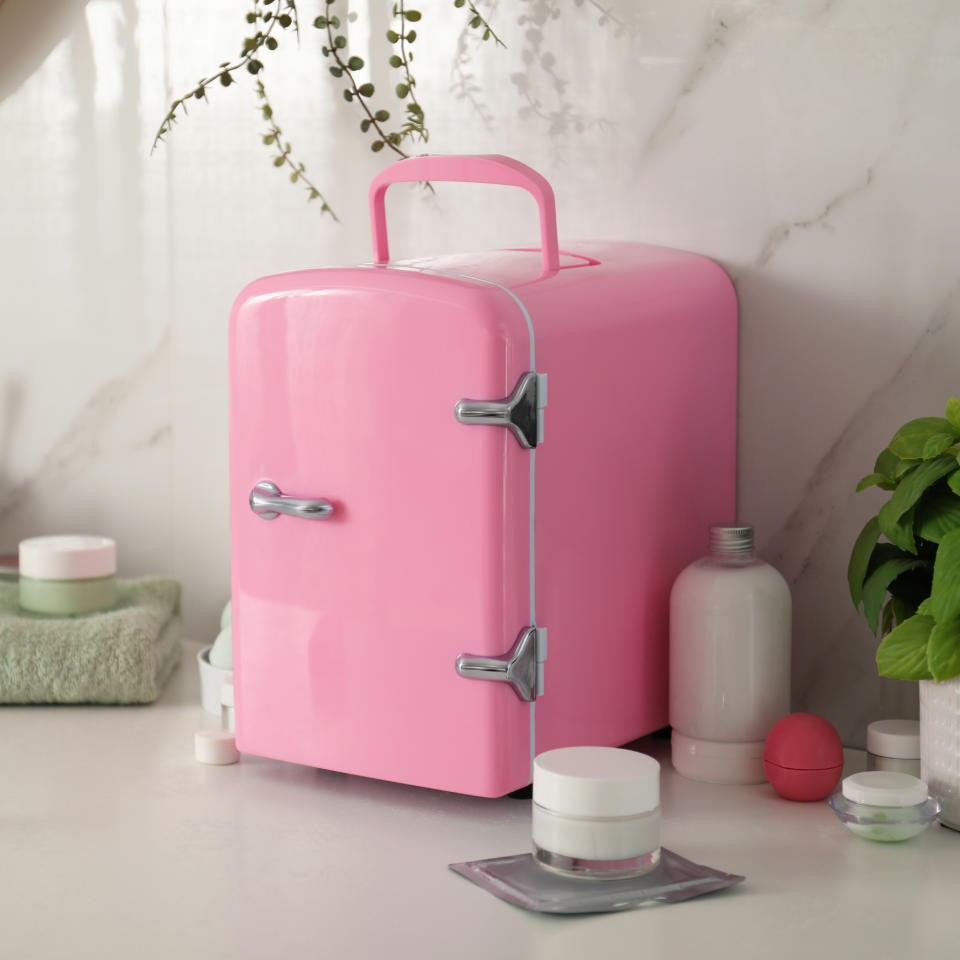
[0,0,960,744]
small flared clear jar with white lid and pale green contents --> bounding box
[830,770,940,843]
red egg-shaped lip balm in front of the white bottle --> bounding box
[763,713,843,802]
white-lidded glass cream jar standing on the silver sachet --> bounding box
[533,747,660,879]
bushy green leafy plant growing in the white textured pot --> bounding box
[847,397,960,681]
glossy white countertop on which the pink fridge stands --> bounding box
[0,644,960,960]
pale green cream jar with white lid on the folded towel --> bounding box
[20,536,117,617]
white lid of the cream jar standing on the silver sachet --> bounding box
[533,747,660,817]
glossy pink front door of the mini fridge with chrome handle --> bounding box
[230,267,532,796]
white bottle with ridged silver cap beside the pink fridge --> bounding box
[670,525,790,783]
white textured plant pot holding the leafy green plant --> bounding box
[920,677,960,830]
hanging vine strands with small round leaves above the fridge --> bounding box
[153,0,504,222]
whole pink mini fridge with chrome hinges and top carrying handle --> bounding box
[230,156,737,797]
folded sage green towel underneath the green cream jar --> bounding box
[0,577,183,703]
